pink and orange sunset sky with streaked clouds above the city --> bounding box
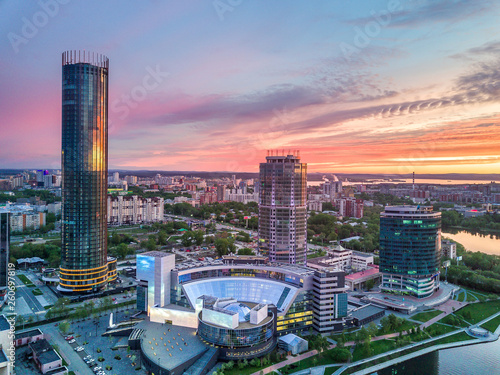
[0,0,500,173]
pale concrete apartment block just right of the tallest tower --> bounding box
[107,195,165,225]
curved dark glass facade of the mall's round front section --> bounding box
[198,313,274,348]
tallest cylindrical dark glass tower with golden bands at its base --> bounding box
[59,51,109,293]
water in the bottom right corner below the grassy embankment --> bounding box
[377,340,500,375]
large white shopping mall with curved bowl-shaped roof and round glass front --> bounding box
[137,251,350,368]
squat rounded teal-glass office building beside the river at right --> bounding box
[380,206,441,298]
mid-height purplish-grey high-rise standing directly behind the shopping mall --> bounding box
[259,155,307,264]
